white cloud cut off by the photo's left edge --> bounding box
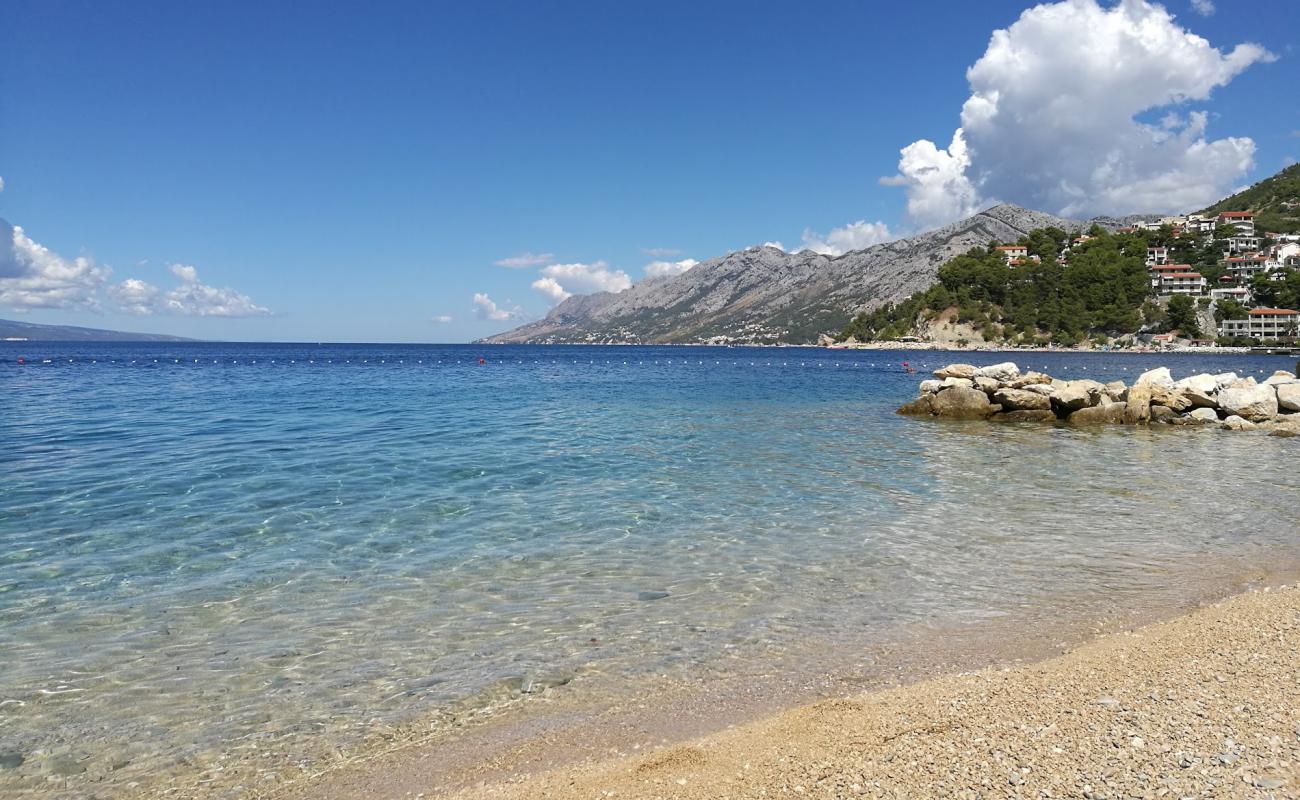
[0,220,112,311]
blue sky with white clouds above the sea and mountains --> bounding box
[0,0,1300,342]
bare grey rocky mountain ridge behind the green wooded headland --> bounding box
[482,206,1125,343]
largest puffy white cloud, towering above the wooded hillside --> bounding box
[883,0,1274,226]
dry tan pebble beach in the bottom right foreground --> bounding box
[279,588,1300,800]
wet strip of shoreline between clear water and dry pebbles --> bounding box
[257,554,1300,800]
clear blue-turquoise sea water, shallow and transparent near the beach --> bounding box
[0,343,1300,796]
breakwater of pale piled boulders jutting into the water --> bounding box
[898,362,1300,436]
